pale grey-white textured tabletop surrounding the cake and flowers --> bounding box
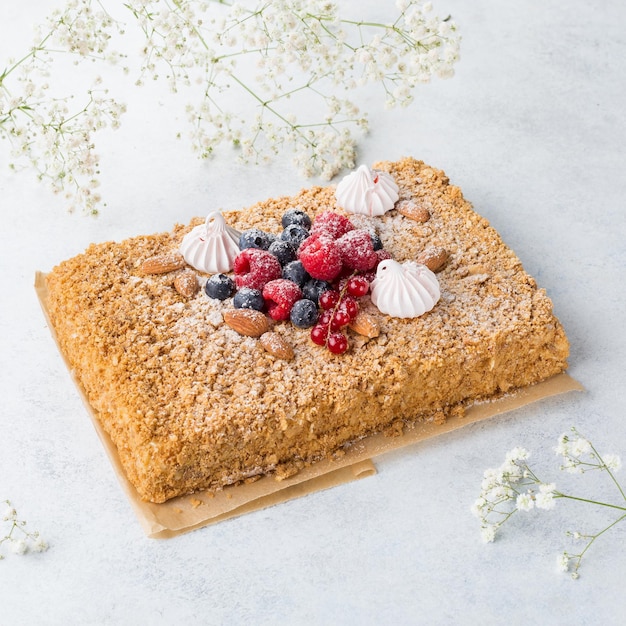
[0,0,626,625]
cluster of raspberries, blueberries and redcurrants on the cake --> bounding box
[205,209,390,354]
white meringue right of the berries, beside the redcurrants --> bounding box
[371,259,441,318]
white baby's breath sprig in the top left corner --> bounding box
[0,0,125,214]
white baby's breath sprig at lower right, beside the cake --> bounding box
[472,428,626,578]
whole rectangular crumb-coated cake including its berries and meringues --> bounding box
[46,158,568,503]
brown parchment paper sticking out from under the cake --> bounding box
[35,272,583,538]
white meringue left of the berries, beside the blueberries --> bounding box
[179,211,241,274]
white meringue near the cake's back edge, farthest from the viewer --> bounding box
[335,165,400,217]
